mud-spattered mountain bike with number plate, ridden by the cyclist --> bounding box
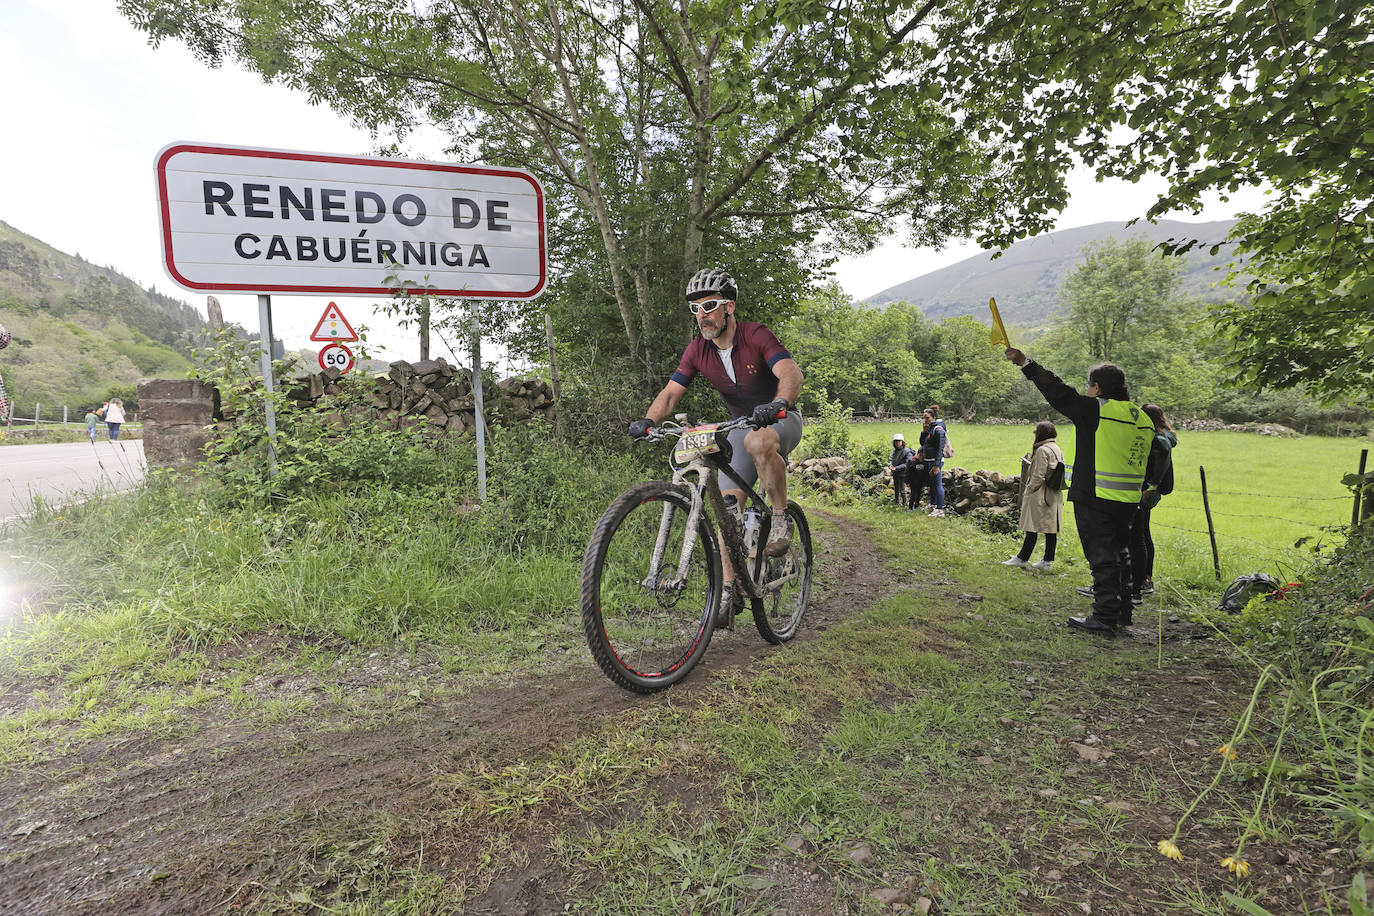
[581,415,813,694]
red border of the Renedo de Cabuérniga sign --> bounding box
[157,143,548,299]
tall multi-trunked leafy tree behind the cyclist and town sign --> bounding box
[120,0,1062,386]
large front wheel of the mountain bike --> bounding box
[581,481,721,694]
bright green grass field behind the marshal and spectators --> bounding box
[851,422,1374,585]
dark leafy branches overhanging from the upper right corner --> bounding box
[938,0,1374,401]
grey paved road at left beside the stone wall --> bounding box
[0,438,144,520]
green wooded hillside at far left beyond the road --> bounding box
[0,222,206,416]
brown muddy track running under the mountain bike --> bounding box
[0,515,899,915]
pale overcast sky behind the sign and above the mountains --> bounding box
[0,0,1259,358]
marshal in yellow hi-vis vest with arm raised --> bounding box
[1006,347,1154,637]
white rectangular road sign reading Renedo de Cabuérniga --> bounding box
[157,143,547,299]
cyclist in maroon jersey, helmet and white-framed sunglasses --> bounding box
[629,268,802,614]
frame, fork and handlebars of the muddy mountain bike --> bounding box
[643,415,801,615]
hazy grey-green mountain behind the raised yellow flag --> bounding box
[864,220,1235,327]
